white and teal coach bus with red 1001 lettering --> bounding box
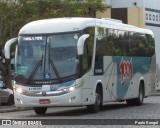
[5,17,156,114]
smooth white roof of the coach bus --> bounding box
[19,17,153,35]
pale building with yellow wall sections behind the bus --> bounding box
[96,0,160,90]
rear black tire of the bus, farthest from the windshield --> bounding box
[126,84,144,106]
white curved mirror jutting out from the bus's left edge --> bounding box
[4,38,17,59]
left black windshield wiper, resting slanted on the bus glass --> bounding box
[27,54,43,81]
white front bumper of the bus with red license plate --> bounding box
[14,88,82,107]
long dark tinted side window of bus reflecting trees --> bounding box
[96,28,155,57]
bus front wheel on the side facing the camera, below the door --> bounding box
[87,92,101,113]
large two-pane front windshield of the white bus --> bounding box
[15,33,79,82]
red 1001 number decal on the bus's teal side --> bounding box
[120,59,132,82]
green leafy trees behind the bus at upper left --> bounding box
[0,0,105,89]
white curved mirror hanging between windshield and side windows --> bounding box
[77,34,89,55]
